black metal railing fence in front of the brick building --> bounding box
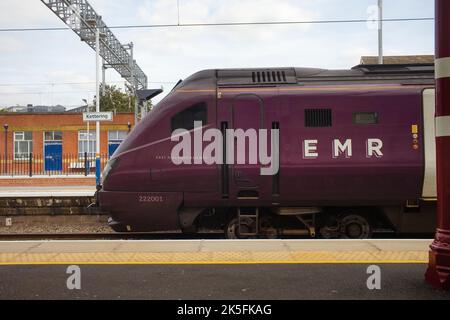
[0,152,109,177]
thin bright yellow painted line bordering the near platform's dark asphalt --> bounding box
[0,260,428,266]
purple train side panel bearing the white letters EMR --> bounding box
[278,90,424,205]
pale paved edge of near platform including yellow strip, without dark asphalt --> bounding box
[0,240,432,265]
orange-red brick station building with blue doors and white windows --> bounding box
[0,112,134,184]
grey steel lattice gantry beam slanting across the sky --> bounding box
[41,0,147,90]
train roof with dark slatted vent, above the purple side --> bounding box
[177,64,435,87]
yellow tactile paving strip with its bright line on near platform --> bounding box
[0,251,428,266]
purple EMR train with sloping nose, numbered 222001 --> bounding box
[97,64,436,238]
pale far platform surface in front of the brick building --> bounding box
[0,186,95,198]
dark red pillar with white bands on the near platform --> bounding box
[425,0,450,290]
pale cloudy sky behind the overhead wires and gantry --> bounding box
[0,0,434,108]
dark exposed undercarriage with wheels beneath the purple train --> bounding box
[184,202,435,239]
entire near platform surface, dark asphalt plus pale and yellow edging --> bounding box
[0,239,450,300]
